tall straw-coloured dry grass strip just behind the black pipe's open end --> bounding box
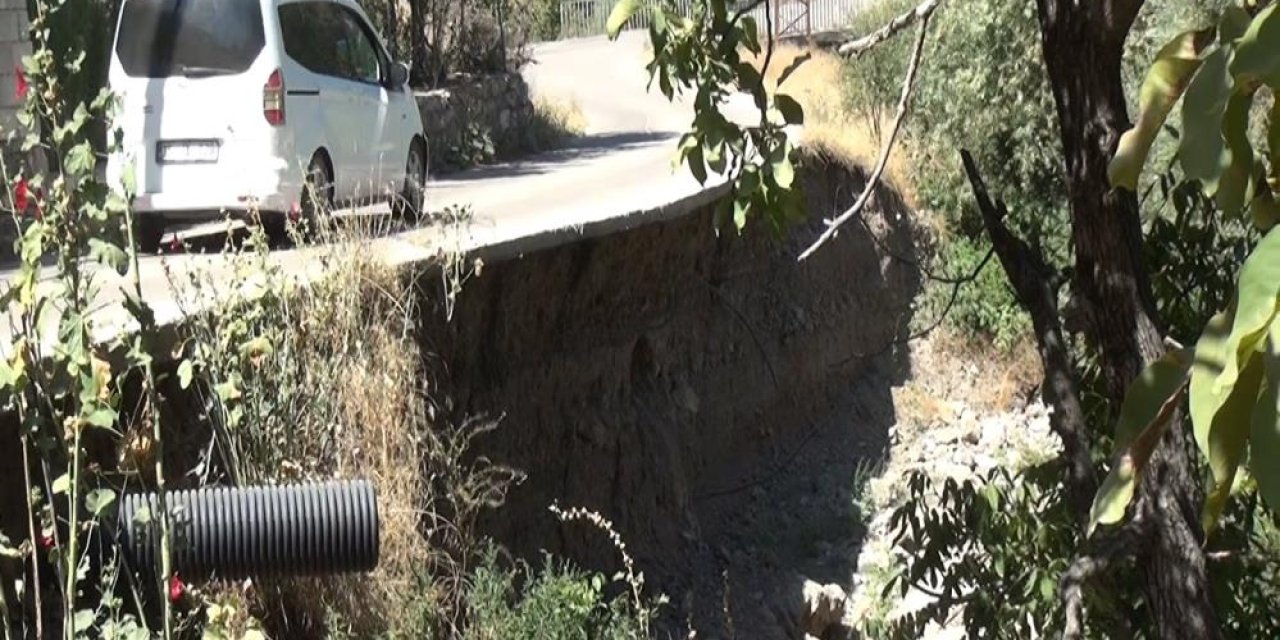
[288,253,428,636]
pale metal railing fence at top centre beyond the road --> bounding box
[559,0,874,38]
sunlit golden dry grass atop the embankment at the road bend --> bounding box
[742,45,915,209]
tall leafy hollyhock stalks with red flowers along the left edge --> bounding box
[0,1,174,637]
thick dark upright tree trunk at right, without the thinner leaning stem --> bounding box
[1037,0,1221,639]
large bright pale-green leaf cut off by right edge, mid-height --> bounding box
[1213,229,1280,393]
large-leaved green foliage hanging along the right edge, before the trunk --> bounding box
[1091,3,1280,540]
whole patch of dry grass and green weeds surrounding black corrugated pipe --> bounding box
[168,228,430,637]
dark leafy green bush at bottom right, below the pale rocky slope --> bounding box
[864,461,1133,639]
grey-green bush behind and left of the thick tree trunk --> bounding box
[846,0,1054,347]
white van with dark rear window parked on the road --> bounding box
[108,0,428,248]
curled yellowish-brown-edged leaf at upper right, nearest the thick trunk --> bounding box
[1107,29,1213,191]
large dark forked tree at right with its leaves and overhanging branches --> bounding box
[611,0,1280,639]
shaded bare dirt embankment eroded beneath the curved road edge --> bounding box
[421,152,919,637]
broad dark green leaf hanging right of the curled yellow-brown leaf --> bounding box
[1178,49,1234,186]
